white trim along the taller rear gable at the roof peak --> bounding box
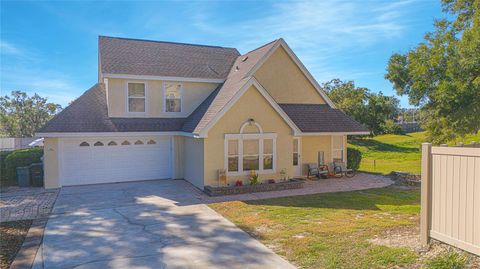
[245,38,335,108]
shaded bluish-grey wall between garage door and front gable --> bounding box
[183,137,203,189]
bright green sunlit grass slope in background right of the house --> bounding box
[348,132,480,174]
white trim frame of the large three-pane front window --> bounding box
[224,133,277,176]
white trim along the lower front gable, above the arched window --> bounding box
[194,77,301,138]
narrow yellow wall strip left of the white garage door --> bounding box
[43,138,60,189]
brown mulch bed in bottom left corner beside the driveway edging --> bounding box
[0,220,32,268]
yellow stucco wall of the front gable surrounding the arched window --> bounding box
[202,86,293,186]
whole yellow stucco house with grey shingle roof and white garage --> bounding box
[37,36,368,188]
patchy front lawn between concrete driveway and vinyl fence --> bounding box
[210,187,420,268]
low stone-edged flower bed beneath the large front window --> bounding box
[204,179,304,196]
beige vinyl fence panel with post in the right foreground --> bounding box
[421,143,480,255]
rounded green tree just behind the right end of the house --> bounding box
[322,79,400,135]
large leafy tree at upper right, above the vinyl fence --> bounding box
[385,0,480,143]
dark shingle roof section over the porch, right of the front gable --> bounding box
[279,104,369,133]
